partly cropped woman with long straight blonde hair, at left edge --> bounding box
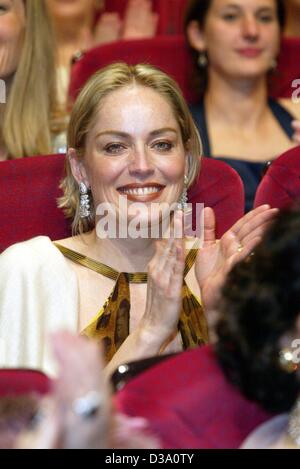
[0,0,60,160]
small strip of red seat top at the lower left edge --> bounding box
[0,368,51,397]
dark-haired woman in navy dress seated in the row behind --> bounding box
[185,0,300,210]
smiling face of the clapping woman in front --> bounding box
[73,85,187,234]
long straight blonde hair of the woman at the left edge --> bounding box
[2,0,56,159]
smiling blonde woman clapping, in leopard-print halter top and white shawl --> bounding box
[0,64,277,373]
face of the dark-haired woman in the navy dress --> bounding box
[190,0,280,78]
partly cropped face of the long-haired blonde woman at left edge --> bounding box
[0,0,25,79]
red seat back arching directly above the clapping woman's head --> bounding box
[69,36,197,102]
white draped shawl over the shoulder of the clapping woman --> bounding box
[0,236,79,375]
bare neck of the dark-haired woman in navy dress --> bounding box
[204,73,268,129]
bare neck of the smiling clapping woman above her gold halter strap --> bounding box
[78,230,155,272]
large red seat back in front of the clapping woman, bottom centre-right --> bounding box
[115,346,269,449]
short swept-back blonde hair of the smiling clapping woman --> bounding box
[59,63,202,234]
